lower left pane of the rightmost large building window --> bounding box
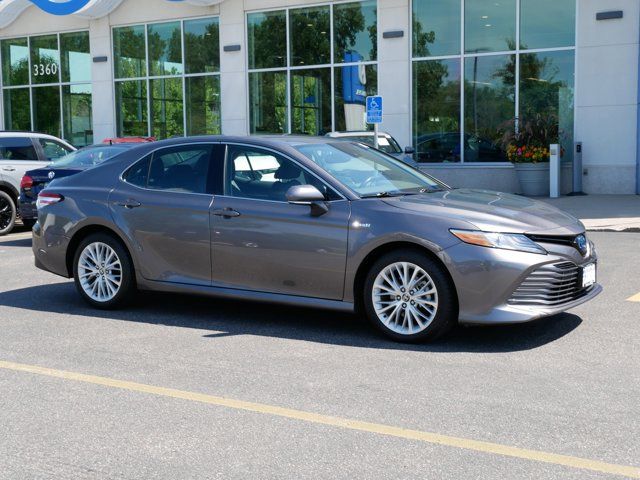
[413,59,460,162]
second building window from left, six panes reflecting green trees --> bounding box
[113,17,221,139]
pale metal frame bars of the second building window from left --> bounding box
[110,14,222,138]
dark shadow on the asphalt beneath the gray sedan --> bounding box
[0,282,582,353]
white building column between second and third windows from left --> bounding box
[220,0,249,135]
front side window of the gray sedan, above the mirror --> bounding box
[225,146,340,202]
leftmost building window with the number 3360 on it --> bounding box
[0,31,93,147]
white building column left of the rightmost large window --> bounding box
[378,0,412,147]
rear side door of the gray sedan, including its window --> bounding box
[109,143,220,286]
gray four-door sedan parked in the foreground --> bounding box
[33,136,602,342]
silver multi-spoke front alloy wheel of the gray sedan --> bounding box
[372,262,438,335]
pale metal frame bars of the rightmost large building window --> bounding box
[408,0,580,164]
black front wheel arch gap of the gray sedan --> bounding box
[353,240,459,312]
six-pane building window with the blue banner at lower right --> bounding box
[247,0,378,135]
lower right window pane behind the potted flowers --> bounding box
[520,50,574,160]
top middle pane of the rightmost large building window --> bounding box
[464,0,516,53]
